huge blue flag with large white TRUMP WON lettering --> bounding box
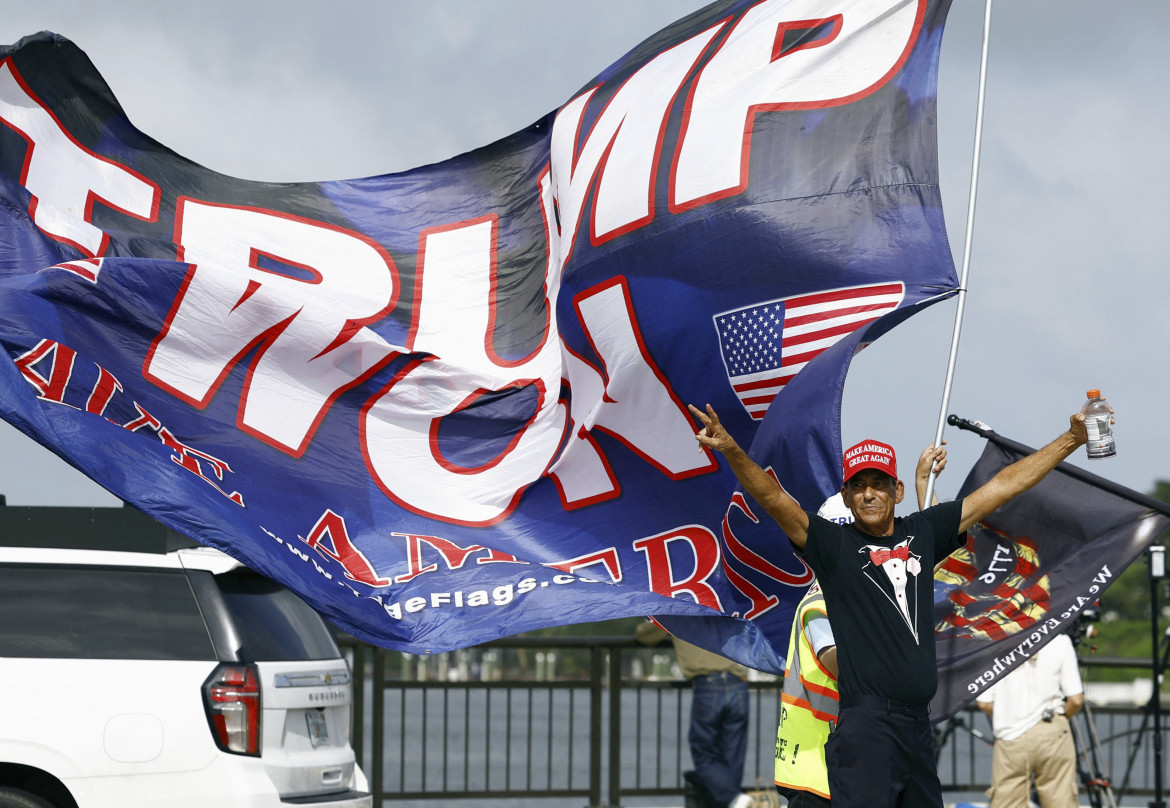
[0,0,956,670]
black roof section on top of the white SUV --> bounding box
[0,502,201,553]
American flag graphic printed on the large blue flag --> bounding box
[713,283,906,421]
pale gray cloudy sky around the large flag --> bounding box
[0,0,1170,505]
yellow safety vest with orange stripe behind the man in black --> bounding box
[776,582,840,799]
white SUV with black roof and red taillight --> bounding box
[0,500,372,808]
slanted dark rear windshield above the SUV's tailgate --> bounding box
[215,568,342,662]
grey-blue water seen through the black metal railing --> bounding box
[364,683,1170,808]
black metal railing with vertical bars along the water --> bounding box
[336,636,1165,807]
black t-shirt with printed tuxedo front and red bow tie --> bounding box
[798,500,963,704]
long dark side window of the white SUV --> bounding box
[0,565,215,659]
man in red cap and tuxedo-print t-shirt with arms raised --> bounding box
[690,405,1087,808]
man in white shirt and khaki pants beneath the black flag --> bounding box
[978,634,1085,808]
